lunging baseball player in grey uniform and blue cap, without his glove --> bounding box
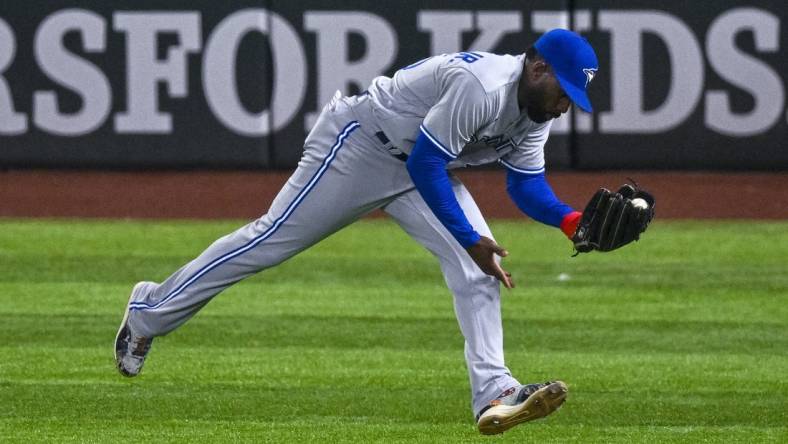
[115,29,598,434]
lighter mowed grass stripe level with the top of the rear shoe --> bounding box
[0,282,788,325]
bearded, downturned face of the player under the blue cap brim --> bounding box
[526,60,571,123]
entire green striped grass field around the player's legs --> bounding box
[0,220,788,443]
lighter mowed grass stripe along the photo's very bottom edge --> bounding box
[0,417,786,443]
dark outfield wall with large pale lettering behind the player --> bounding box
[0,0,788,171]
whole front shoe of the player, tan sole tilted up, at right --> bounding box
[476,381,568,435]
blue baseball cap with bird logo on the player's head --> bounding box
[534,29,599,113]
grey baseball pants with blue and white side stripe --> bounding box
[129,96,518,414]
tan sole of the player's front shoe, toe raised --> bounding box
[479,381,569,435]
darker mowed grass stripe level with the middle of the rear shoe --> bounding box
[0,314,788,355]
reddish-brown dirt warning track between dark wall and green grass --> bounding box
[0,170,788,219]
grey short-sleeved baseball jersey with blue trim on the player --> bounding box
[368,52,552,174]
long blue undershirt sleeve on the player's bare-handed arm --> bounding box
[406,133,481,248]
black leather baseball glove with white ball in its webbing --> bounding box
[572,181,655,254]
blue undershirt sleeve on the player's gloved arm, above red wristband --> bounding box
[506,170,574,227]
